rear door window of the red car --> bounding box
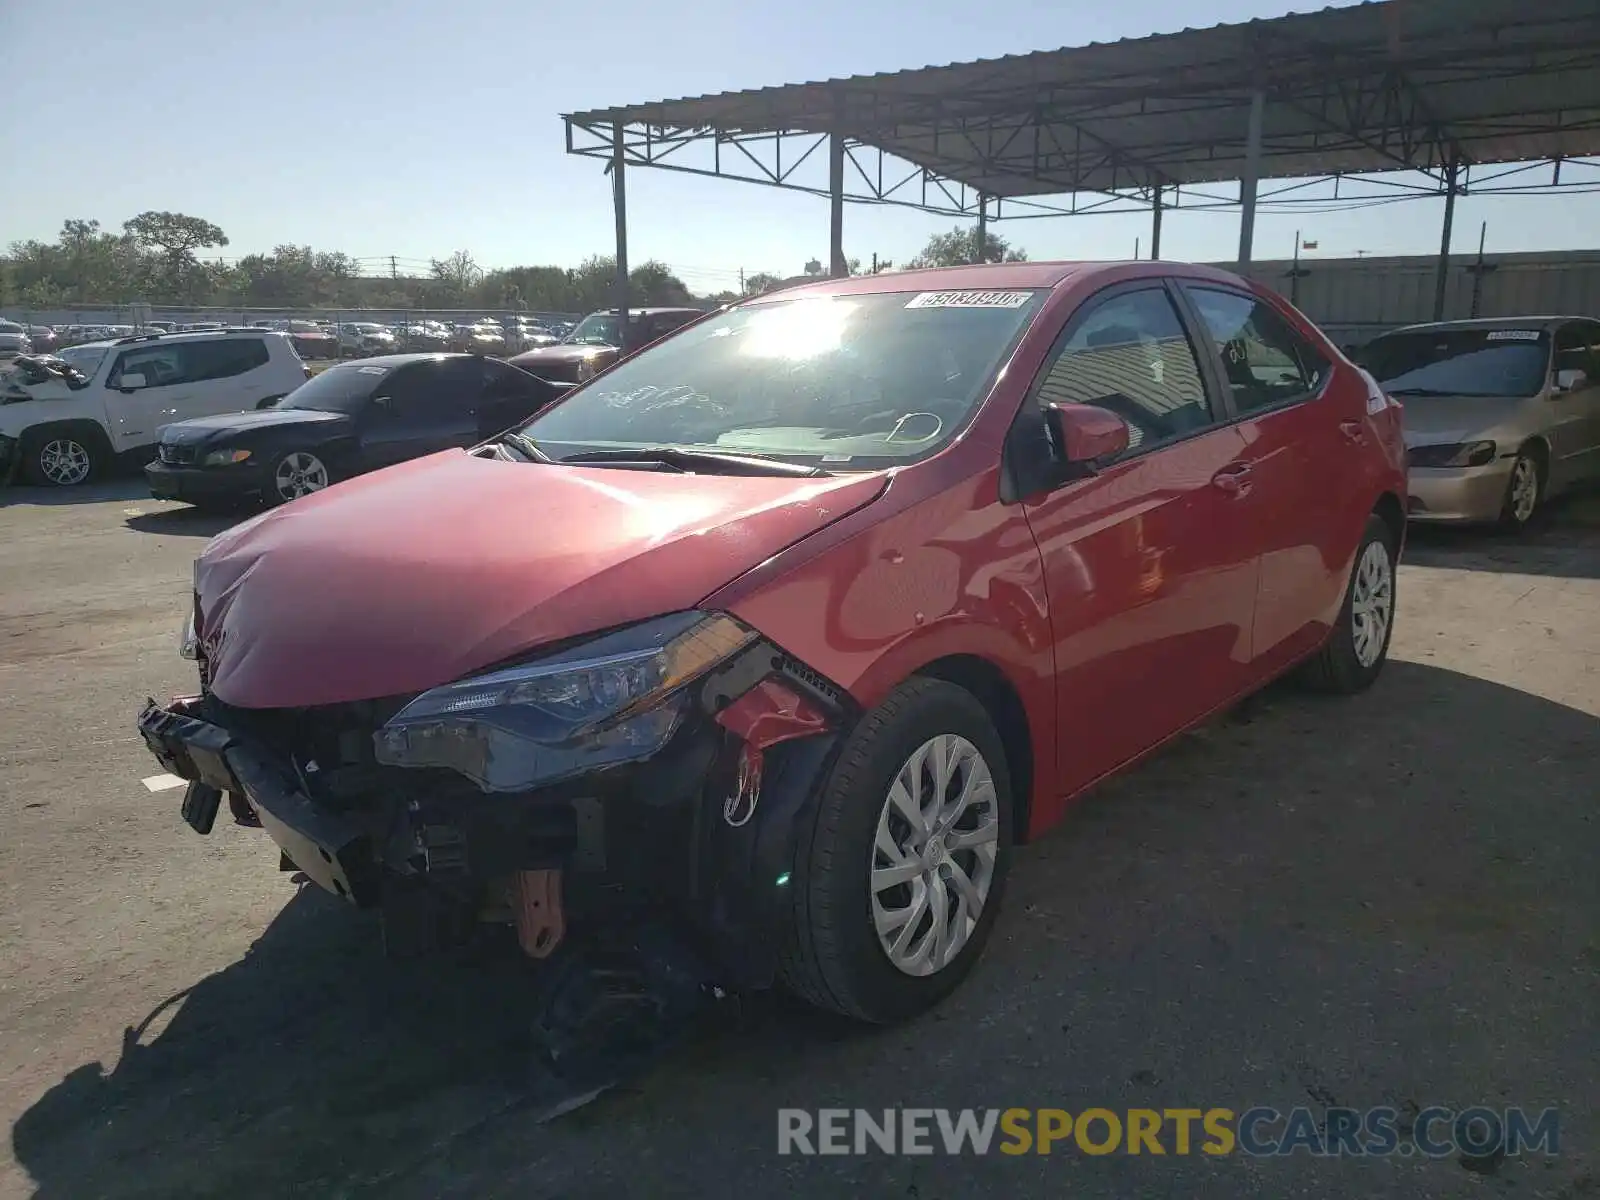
[1186,288,1328,414]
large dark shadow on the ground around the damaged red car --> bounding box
[13,662,1600,1200]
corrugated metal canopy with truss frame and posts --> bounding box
[563,0,1600,324]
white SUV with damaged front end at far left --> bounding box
[0,330,310,486]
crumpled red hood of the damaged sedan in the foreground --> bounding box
[195,451,885,709]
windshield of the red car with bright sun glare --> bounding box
[523,291,1043,470]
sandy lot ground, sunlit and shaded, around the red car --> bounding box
[0,483,1600,1200]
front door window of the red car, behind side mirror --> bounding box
[1038,288,1213,450]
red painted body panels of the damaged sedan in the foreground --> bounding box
[198,262,1405,832]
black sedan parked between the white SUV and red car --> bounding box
[144,354,565,507]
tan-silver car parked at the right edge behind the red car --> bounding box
[1358,317,1600,530]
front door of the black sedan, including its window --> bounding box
[362,358,483,469]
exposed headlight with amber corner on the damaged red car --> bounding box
[373,613,755,792]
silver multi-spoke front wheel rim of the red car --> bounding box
[869,733,1000,976]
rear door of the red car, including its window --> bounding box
[1182,283,1373,678]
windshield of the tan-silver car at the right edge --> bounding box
[1360,330,1550,397]
